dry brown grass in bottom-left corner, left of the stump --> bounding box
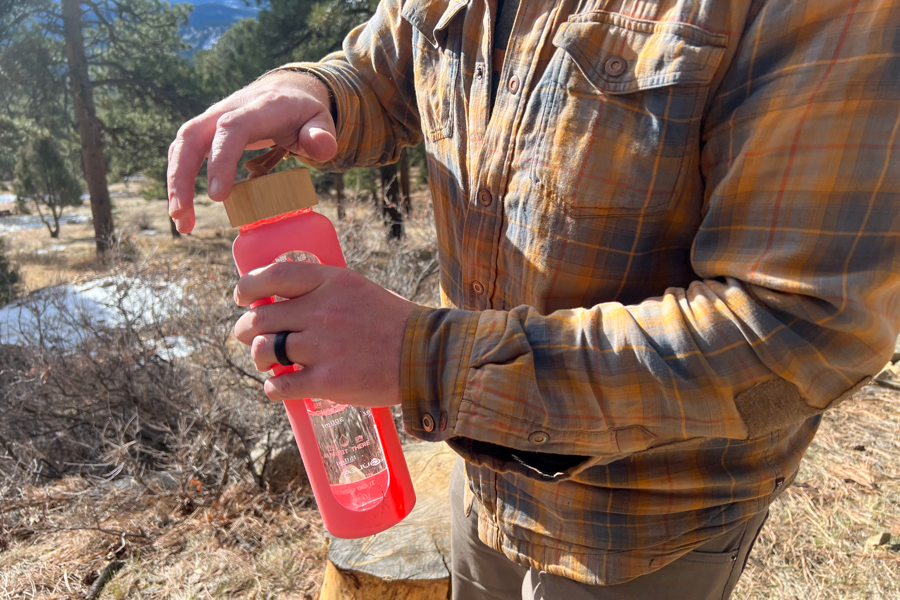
[0,480,326,600]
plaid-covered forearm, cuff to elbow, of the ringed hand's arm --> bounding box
[401,272,896,478]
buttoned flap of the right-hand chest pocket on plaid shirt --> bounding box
[553,11,728,94]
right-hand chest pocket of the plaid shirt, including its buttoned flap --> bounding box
[532,11,727,217]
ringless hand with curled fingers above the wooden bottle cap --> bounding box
[168,71,337,233]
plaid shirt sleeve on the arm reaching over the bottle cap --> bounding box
[267,0,422,171]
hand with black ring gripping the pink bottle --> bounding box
[234,262,416,407]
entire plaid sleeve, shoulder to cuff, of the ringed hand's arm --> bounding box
[401,2,900,478]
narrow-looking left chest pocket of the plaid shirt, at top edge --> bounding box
[401,0,467,141]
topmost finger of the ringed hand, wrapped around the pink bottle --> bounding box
[234,262,340,310]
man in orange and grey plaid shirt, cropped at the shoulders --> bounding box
[169,0,900,600]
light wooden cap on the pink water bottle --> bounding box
[224,167,319,227]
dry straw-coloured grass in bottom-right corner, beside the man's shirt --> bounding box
[734,387,900,600]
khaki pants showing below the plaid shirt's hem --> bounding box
[450,459,768,600]
